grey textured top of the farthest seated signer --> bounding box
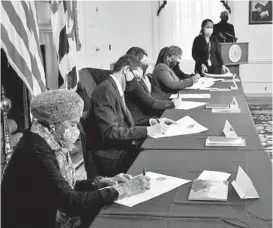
[152,63,193,99]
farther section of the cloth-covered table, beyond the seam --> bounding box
[141,82,264,151]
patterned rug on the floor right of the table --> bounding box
[249,104,272,159]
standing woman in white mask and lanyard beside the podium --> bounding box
[192,19,230,76]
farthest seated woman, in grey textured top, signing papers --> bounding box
[152,46,200,99]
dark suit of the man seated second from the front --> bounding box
[84,77,149,175]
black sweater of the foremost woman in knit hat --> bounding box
[1,131,118,228]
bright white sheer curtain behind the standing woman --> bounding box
[158,0,225,73]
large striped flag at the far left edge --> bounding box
[1,1,46,96]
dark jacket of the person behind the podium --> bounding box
[213,21,235,42]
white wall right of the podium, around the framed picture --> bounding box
[229,1,272,96]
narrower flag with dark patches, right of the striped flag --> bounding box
[51,0,79,89]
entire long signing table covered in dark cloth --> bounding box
[91,78,272,228]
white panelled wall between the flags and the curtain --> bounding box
[78,1,154,69]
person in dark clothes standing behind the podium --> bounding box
[214,11,234,42]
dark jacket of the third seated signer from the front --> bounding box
[125,77,175,122]
